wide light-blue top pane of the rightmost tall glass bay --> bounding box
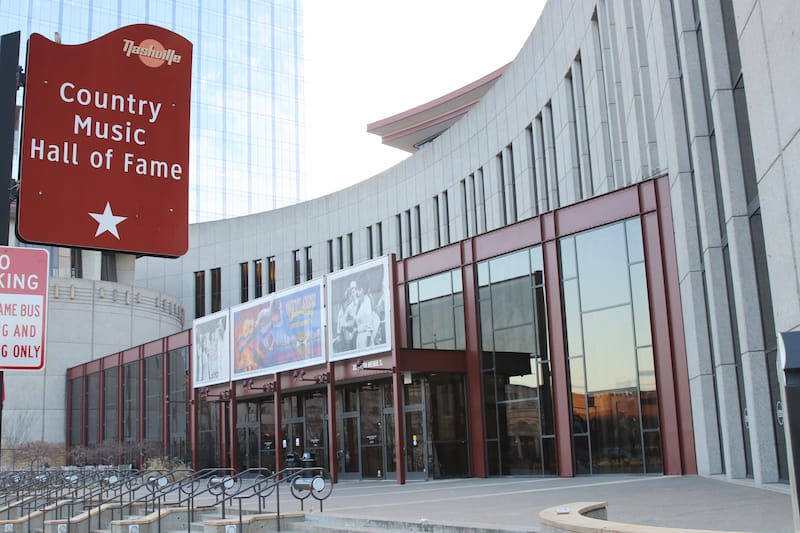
[575,224,630,312]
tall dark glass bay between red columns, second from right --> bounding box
[478,247,555,474]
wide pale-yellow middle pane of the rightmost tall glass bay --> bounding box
[583,305,637,391]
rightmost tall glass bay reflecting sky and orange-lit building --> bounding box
[560,219,662,474]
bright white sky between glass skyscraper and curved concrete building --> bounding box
[303,0,545,199]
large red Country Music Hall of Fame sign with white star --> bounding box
[17,24,192,257]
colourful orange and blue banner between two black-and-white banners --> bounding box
[231,280,325,379]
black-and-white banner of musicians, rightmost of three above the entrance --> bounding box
[327,257,392,361]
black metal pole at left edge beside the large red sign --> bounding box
[0,32,19,466]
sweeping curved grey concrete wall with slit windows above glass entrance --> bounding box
[136,0,800,482]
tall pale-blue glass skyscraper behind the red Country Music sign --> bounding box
[0,0,305,222]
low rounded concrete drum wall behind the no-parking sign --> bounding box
[3,278,184,446]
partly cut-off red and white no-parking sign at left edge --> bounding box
[0,246,49,370]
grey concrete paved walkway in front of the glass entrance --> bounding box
[281,475,795,533]
